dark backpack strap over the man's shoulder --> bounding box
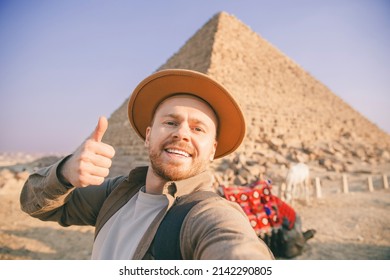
[149,191,220,260]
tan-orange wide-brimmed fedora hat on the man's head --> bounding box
[128,69,246,158]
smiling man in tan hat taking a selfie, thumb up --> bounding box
[21,69,273,259]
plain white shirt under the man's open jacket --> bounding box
[91,191,168,260]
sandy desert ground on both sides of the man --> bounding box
[0,166,390,260]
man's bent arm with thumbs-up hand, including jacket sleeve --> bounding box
[20,118,119,226]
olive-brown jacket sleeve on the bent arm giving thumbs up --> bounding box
[20,158,125,226]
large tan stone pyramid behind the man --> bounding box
[103,12,390,178]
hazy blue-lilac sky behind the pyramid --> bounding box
[0,0,390,153]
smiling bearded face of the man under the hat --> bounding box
[145,95,217,181]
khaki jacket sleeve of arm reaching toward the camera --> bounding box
[180,198,274,260]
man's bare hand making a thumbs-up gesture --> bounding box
[59,117,115,187]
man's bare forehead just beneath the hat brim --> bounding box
[154,94,218,124]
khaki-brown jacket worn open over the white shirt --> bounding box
[20,161,273,260]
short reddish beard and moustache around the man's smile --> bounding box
[149,141,209,181]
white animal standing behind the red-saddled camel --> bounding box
[283,163,310,204]
